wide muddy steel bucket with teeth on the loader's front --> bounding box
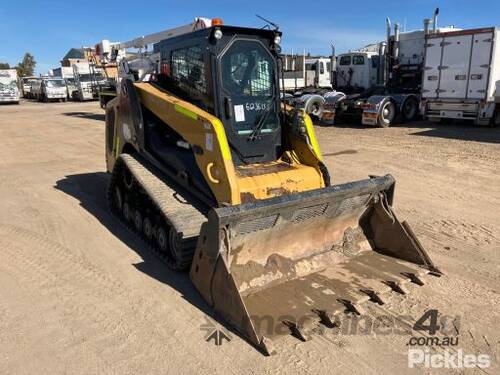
[190,175,440,354]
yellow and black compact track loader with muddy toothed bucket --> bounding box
[103,19,440,354]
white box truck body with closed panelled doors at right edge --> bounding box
[421,27,500,126]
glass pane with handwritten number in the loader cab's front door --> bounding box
[221,40,278,135]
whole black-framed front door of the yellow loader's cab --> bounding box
[217,38,281,164]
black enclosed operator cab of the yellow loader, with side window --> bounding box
[154,25,282,165]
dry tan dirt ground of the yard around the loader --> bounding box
[0,102,500,374]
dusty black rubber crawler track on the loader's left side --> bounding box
[107,154,207,269]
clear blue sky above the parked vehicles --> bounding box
[0,0,500,73]
